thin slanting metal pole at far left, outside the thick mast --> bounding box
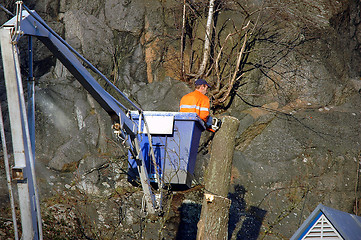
[0,103,19,240]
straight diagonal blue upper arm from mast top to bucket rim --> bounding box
[2,10,137,135]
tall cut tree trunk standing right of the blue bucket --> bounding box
[197,116,239,240]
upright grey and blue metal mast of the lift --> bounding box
[0,27,42,240]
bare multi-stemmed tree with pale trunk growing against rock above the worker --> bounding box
[176,0,302,111]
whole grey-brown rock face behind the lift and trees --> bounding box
[0,0,361,239]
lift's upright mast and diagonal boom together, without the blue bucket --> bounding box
[0,1,162,229]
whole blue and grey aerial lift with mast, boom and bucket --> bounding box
[0,1,205,239]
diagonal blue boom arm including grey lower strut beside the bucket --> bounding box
[0,6,159,227]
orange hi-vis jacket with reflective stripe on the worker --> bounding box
[179,90,210,122]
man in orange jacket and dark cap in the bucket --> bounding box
[179,79,214,132]
